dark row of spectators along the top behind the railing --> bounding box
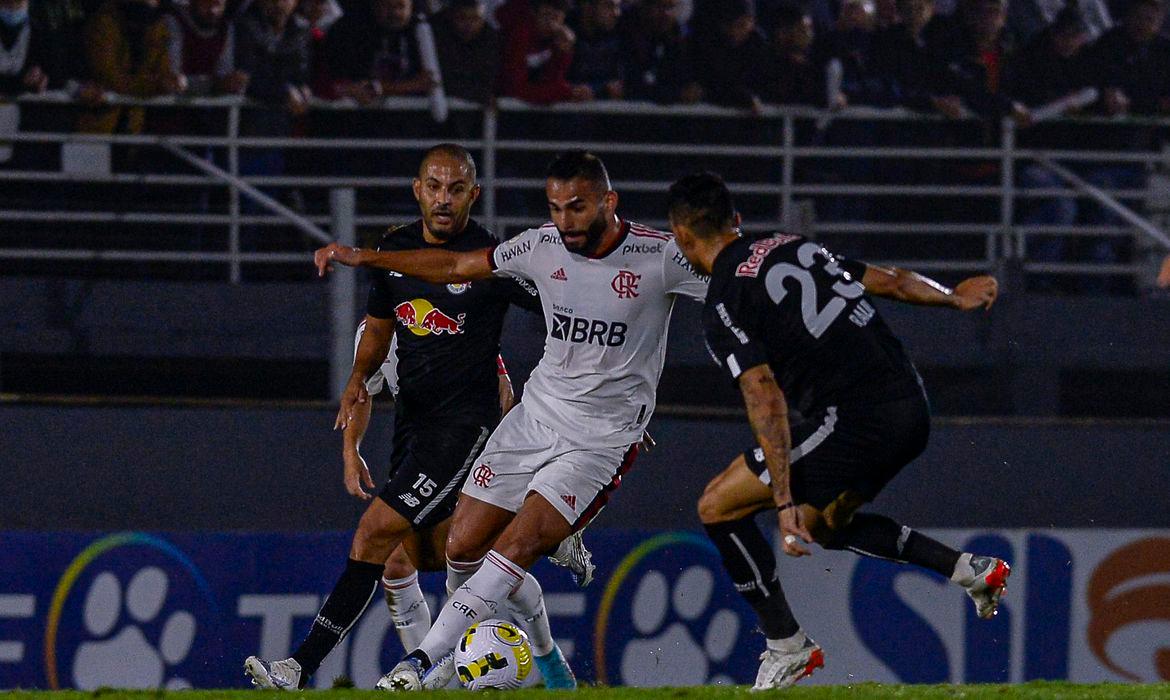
[0,0,1170,119]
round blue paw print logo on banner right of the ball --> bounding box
[594,533,756,687]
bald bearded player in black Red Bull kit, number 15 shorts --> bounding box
[245,144,580,689]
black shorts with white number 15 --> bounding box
[378,419,491,529]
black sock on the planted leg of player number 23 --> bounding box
[703,516,800,639]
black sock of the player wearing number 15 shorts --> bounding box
[293,560,383,685]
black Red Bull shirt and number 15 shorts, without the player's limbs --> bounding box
[366,220,541,527]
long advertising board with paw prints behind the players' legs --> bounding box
[0,528,1170,689]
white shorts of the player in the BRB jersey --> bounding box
[463,402,638,531]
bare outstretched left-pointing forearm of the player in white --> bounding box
[312,242,491,282]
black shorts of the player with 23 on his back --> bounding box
[743,394,930,509]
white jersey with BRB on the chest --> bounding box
[493,222,707,447]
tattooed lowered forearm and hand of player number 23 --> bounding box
[739,364,812,556]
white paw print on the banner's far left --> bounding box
[73,567,195,691]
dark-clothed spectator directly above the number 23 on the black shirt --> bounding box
[761,5,825,107]
